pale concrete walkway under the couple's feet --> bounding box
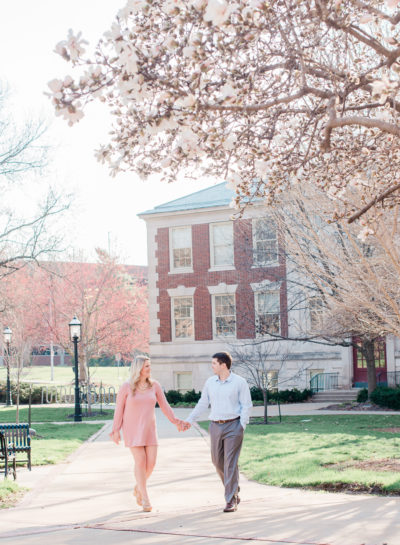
[0,406,400,545]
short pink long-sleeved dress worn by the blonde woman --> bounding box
[110,381,176,447]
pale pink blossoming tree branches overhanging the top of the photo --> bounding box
[49,0,400,236]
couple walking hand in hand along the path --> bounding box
[110,352,252,513]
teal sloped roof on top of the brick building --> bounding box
[139,182,235,216]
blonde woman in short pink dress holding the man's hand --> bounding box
[110,356,183,512]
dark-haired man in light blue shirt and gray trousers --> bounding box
[187,352,253,513]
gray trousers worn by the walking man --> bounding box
[209,419,244,503]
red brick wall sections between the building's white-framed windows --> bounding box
[156,220,287,342]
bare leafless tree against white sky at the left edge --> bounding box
[0,86,70,278]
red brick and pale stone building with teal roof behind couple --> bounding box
[139,183,395,390]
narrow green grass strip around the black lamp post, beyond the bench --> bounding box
[0,405,114,423]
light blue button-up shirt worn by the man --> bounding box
[187,372,253,429]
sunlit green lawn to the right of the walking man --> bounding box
[202,415,400,495]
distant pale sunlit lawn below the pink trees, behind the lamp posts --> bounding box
[0,366,129,388]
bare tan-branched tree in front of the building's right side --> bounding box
[274,184,400,393]
